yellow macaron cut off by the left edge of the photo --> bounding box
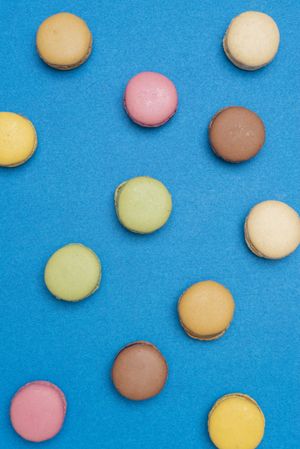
[0,112,37,167]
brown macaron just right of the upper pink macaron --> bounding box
[209,106,265,163]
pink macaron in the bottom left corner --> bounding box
[10,380,67,443]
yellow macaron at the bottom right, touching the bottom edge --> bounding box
[208,393,265,449]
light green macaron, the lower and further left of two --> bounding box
[44,243,102,302]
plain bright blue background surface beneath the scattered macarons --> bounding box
[0,0,300,449]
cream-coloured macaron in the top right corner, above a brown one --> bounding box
[223,11,280,70]
